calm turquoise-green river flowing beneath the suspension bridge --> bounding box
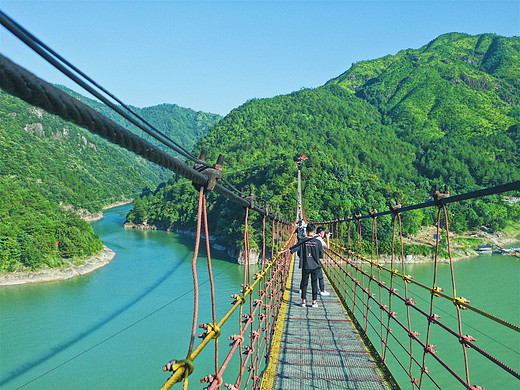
[0,205,520,390]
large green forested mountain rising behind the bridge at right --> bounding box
[128,33,520,253]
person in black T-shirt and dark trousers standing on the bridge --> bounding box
[289,223,323,307]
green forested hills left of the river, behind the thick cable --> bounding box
[0,87,220,271]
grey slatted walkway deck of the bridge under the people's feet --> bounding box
[262,259,389,390]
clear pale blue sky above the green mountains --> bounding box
[0,0,520,115]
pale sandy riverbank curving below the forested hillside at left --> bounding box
[0,246,116,286]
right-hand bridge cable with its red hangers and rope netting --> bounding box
[312,182,520,390]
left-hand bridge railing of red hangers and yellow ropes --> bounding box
[162,193,294,389]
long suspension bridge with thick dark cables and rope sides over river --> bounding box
[0,12,520,390]
